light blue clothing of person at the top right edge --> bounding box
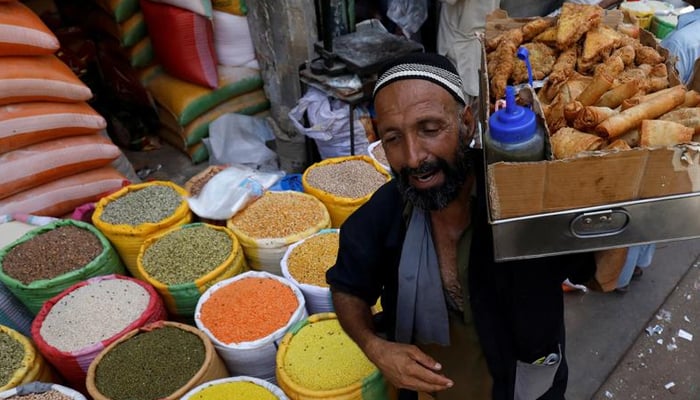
[661,0,700,85]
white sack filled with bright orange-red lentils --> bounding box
[194,271,308,383]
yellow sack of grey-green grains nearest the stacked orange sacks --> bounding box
[92,181,192,279]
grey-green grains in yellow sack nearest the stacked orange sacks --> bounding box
[100,185,182,226]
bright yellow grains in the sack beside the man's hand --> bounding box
[284,318,376,390]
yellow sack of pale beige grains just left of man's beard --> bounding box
[301,155,391,228]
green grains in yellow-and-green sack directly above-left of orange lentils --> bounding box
[142,225,233,285]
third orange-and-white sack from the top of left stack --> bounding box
[0,102,107,153]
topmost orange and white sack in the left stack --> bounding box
[0,1,61,56]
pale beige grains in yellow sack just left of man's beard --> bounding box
[306,160,387,199]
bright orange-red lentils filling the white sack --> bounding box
[200,277,299,344]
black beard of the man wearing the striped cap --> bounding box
[394,135,473,211]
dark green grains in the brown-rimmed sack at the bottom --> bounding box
[95,326,205,400]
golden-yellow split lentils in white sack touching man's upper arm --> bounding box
[287,232,340,287]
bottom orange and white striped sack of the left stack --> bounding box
[0,167,128,217]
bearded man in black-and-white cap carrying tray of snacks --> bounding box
[327,53,595,400]
